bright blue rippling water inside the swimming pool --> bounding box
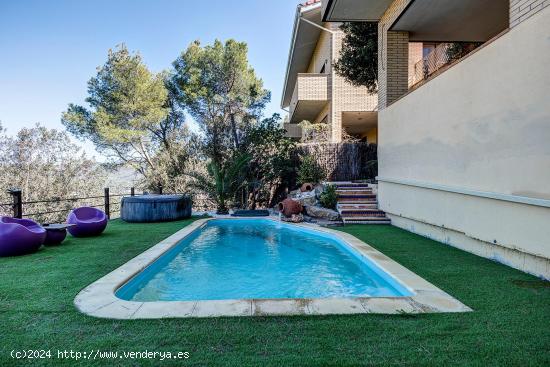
[116,219,410,302]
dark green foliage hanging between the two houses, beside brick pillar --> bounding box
[334,22,378,93]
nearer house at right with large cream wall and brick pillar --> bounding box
[322,0,550,279]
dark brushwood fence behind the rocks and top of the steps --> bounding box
[295,143,378,181]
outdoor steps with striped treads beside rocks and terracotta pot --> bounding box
[332,182,391,224]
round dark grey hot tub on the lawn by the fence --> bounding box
[120,195,192,223]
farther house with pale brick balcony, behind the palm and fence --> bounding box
[281,0,378,143]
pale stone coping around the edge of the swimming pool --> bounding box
[74,218,472,320]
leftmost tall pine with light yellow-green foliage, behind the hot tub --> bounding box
[62,45,189,191]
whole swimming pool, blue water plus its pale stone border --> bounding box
[74,218,471,320]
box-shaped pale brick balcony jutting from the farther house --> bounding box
[289,73,329,124]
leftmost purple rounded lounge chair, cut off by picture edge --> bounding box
[0,217,46,257]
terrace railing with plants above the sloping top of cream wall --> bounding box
[409,42,481,88]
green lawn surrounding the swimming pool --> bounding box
[0,221,550,366]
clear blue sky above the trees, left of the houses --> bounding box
[0,0,300,159]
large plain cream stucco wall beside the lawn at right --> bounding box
[378,7,550,277]
